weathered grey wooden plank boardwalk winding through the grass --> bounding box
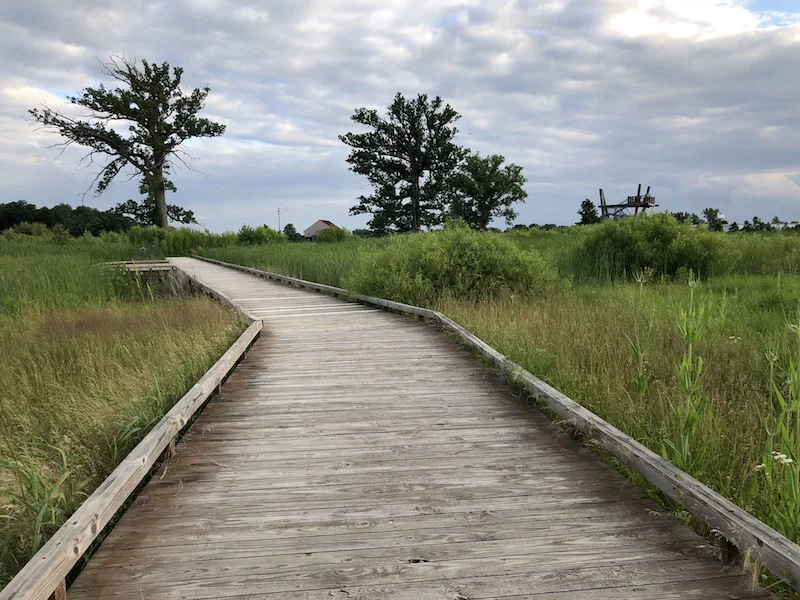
[69,258,766,600]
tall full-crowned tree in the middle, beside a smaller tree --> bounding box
[339,92,465,233]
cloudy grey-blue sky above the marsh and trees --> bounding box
[0,0,800,230]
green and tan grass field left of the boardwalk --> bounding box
[0,239,244,587]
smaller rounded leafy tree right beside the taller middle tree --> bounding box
[450,154,528,229]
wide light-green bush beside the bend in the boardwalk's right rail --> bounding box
[344,223,556,306]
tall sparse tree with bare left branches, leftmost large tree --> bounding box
[29,57,225,227]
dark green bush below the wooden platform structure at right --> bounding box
[574,213,732,279]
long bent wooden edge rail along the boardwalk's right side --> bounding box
[191,256,800,600]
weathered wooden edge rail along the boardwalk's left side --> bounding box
[0,314,263,600]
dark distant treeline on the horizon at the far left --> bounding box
[0,200,137,237]
